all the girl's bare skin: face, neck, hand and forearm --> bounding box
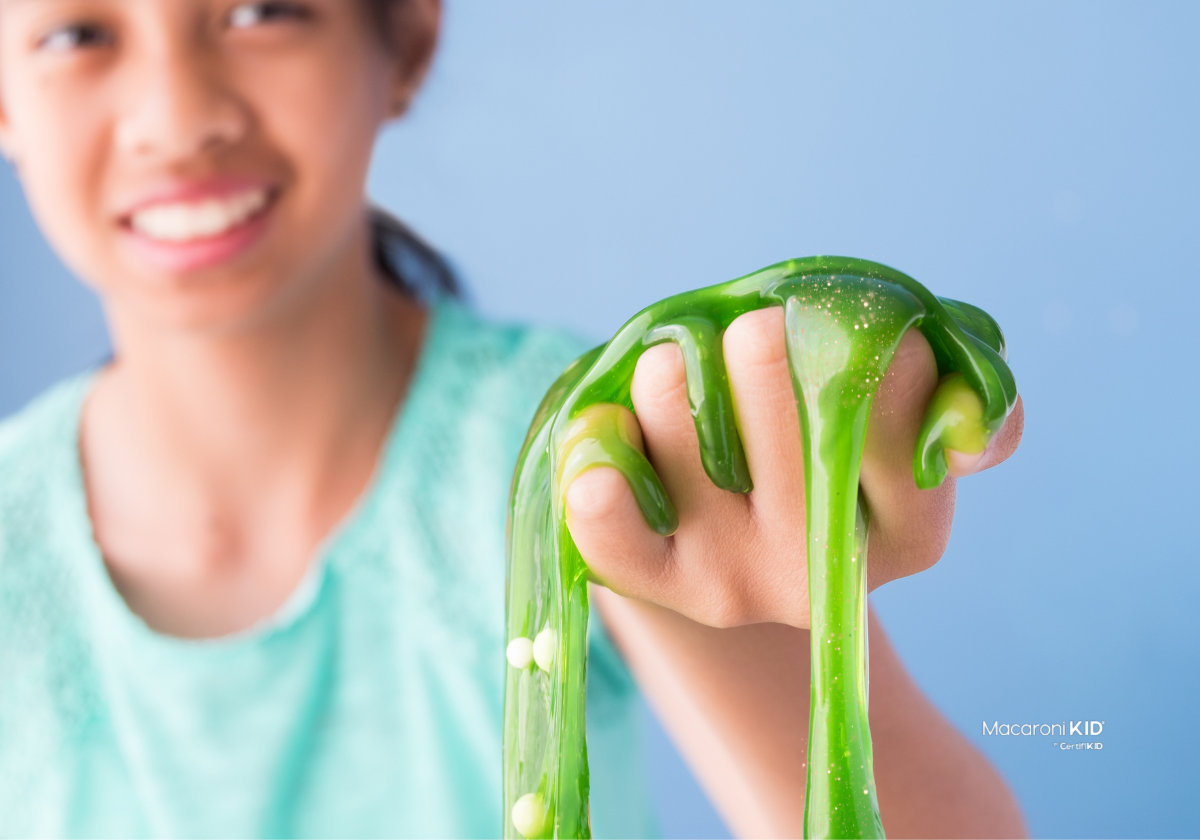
[0,0,1024,836]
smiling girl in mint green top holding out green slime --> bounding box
[0,0,1022,836]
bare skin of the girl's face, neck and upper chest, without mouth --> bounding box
[0,0,438,636]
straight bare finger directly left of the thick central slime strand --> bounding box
[725,306,804,522]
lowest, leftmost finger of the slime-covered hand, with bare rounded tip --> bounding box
[566,467,670,600]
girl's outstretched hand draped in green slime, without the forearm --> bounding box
[566,307,1024,629]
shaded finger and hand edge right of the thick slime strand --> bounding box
[859,330,954,588]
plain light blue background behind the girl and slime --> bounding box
[0,0,1200,838]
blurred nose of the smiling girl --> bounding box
[114,48,251,166]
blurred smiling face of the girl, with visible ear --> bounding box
[0,0,437,331]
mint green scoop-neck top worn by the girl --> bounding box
[0,302,655,838]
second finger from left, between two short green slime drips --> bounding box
[630,343,745,520]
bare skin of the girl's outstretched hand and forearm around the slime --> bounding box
[568,308,1025,838]
